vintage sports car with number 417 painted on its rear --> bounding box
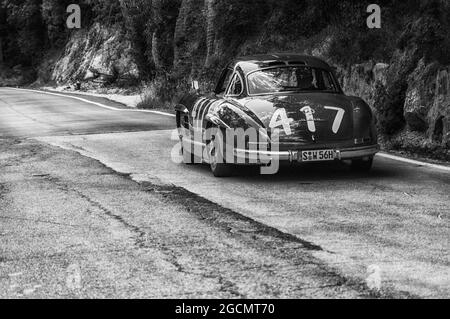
[176,54,379,177]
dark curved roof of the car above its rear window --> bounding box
[231,53,332,73]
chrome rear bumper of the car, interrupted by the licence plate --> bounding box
[234,145,380,163]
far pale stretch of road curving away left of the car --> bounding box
[0,88,173,137]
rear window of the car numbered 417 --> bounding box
[247,66,338,94]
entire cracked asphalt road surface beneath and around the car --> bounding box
[0,89,450,298]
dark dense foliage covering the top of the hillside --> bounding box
[0,0,450,77]
